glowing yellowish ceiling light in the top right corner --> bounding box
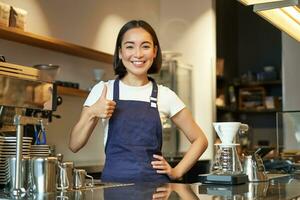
[240,0,300,42]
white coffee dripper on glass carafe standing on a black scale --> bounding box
[198,122,248,185]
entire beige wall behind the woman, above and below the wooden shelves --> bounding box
[0,0,215,165]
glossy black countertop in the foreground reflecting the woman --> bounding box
[0,175,300,200]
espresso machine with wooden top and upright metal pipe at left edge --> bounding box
[0,62,58,197]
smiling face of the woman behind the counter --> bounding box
[119,28,157,76]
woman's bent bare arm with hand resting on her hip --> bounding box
[152,108,208,179]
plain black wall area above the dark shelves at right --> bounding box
[237,3,282,78]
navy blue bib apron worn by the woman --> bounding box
[101,79,169,183]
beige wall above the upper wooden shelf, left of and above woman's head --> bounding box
[1,0,160,53]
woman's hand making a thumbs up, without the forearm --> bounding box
[90,84,116,119]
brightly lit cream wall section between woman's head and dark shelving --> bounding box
[159,0,216,159]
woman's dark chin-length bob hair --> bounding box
[113,20,162,78]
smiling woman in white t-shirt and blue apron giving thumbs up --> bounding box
[69,20,207,182]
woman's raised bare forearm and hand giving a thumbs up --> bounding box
[69,85,116,153]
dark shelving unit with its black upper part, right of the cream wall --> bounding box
[216,0,282,148]
